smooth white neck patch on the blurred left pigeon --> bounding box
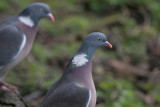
[19,16,34,27]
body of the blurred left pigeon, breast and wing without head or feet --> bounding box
[0,16,38,79]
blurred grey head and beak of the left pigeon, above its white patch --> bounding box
[19,3,54,24]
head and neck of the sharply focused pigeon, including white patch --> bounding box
[67,32,112,68]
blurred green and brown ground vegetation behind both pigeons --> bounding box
[0,0,160,107]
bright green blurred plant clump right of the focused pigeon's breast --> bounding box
[98,73,148,107]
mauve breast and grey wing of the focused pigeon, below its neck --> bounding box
[42,61,96,107]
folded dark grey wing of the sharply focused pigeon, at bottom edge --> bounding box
[40,83,91,107]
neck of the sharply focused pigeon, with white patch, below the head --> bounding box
[67,43,96,68]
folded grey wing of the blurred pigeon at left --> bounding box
[0,25,24,67]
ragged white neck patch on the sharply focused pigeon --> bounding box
[72,53,88,67]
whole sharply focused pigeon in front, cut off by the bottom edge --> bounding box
[40,32,111,107]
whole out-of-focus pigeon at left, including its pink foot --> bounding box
[0,3,54,91]
